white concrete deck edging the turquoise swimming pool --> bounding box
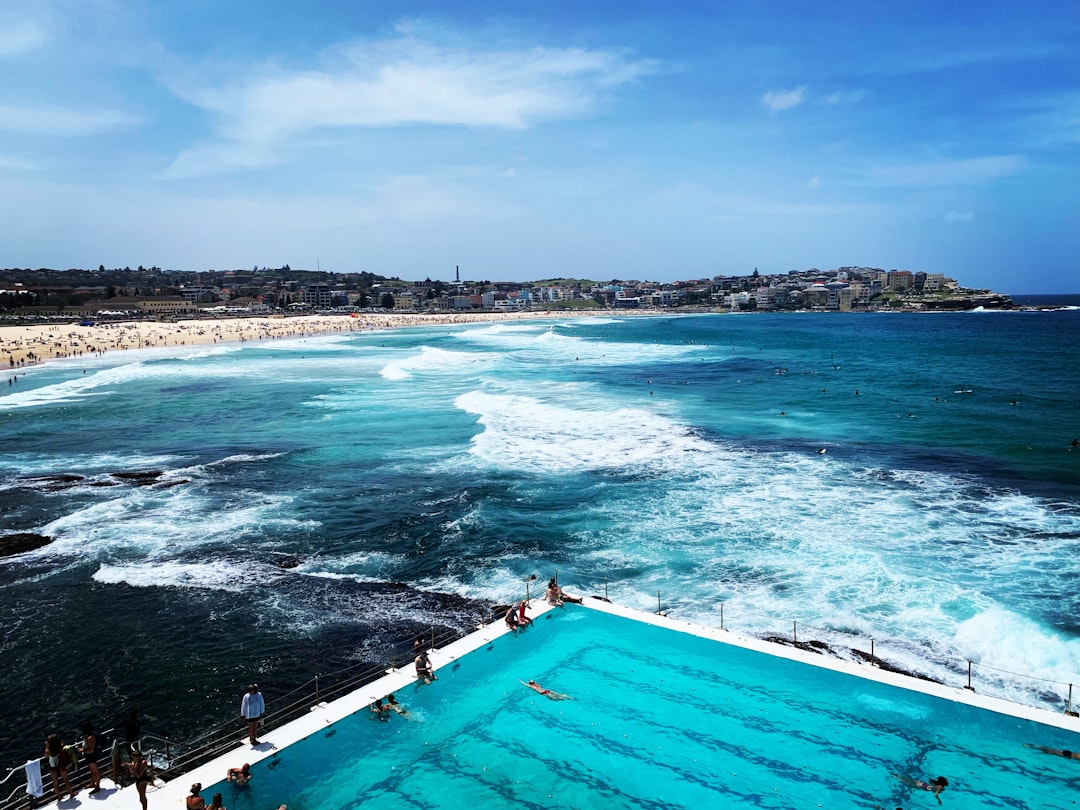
[19,597,1080,810]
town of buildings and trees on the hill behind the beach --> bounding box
[0,265,1012,320]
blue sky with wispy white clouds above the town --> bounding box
[0,0,1080,293]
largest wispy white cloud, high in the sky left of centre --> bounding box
[163,37,656,176]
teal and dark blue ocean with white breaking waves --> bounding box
[0,308,1080,767]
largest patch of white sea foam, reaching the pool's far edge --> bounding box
[442,391,1080,697]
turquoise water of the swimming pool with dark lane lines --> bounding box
[204,606,1080,810]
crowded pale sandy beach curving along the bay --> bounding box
[0,310,622,370]
